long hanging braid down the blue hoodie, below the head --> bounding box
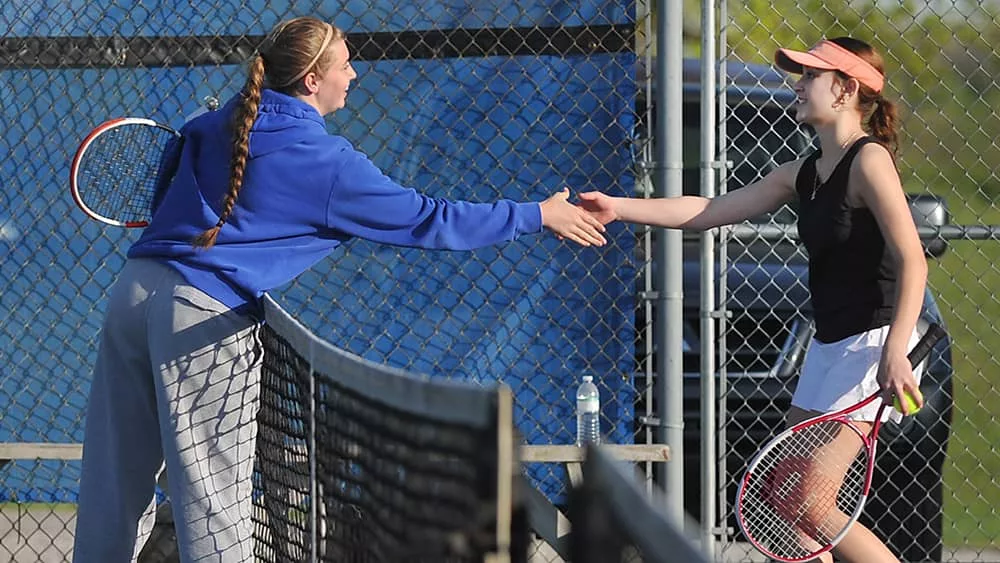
[191,55,264,249]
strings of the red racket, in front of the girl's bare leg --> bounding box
[741,421,868,559]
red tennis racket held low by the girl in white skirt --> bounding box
[736,324,945,562]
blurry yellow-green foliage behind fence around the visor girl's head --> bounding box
[727,0,1000,209]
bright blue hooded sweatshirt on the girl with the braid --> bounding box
[128,89,542,308]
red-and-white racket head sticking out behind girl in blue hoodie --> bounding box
[69,117,181,227]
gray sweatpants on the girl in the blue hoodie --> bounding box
[73,259,261,563]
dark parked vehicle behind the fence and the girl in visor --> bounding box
[636,60,953,561]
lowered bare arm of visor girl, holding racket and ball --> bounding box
[851,143,927,410]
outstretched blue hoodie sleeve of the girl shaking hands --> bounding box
[326,149,542,250]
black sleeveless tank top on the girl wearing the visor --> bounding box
[795,137,898,342]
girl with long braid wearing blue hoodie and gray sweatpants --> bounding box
[74,17,605,563]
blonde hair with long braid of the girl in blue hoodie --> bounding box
[191,17,346,248]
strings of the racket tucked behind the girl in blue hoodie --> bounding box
[77,124,176,222]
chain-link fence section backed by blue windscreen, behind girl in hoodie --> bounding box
[0,0,646,561]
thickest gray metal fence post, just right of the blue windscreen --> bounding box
[653,0,684,523]
